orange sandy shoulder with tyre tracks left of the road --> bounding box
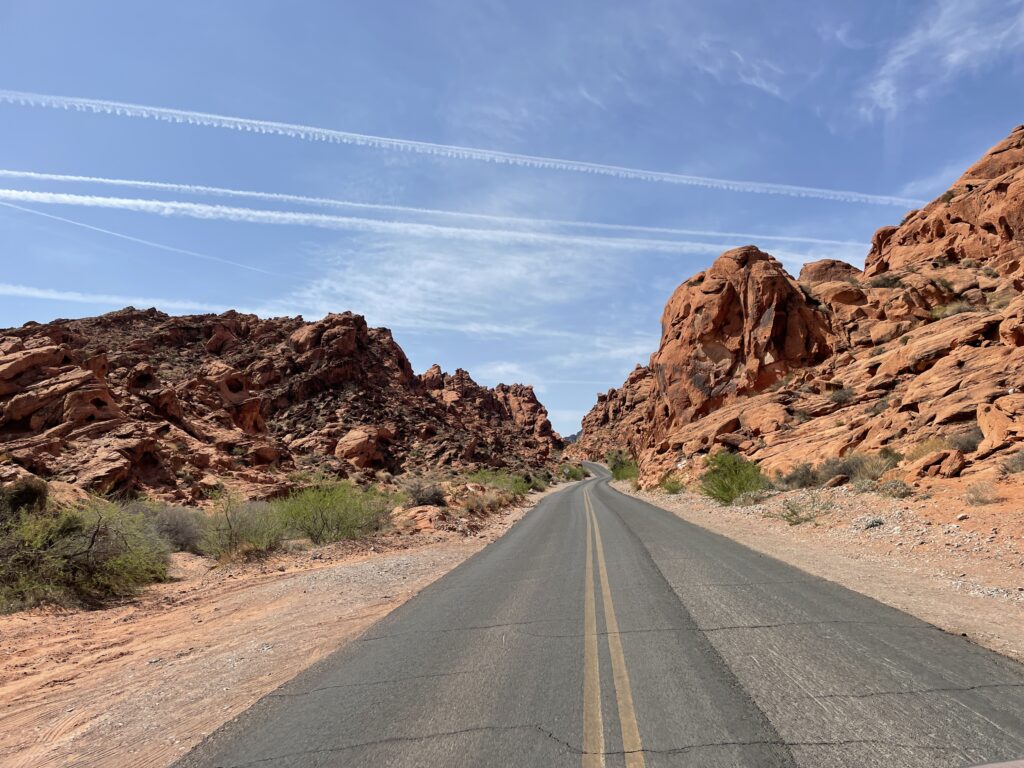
[0,485,566,768]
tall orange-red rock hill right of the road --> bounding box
[568,126,1024,484]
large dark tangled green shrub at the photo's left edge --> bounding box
[0,499,168,612]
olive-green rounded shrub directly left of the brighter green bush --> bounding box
[200,496,288,559]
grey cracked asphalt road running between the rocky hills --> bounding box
[178,466,1024,768]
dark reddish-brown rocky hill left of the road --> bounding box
[0,308,561,502]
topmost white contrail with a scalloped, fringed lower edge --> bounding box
[0,90,925,208]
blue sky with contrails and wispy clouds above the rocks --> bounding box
[0,0,1024,434]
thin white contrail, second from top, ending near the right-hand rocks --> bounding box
[0,169,865,248]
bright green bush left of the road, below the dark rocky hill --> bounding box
[274,482,398,549]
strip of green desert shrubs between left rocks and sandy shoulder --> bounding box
[0,463,589,612]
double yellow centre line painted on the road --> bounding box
[583,489,645,768]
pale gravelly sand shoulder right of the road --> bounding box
[612,478,1024,662]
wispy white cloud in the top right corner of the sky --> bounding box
[860,0,1024,119]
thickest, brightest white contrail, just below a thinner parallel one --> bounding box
[0,189,753,254]
